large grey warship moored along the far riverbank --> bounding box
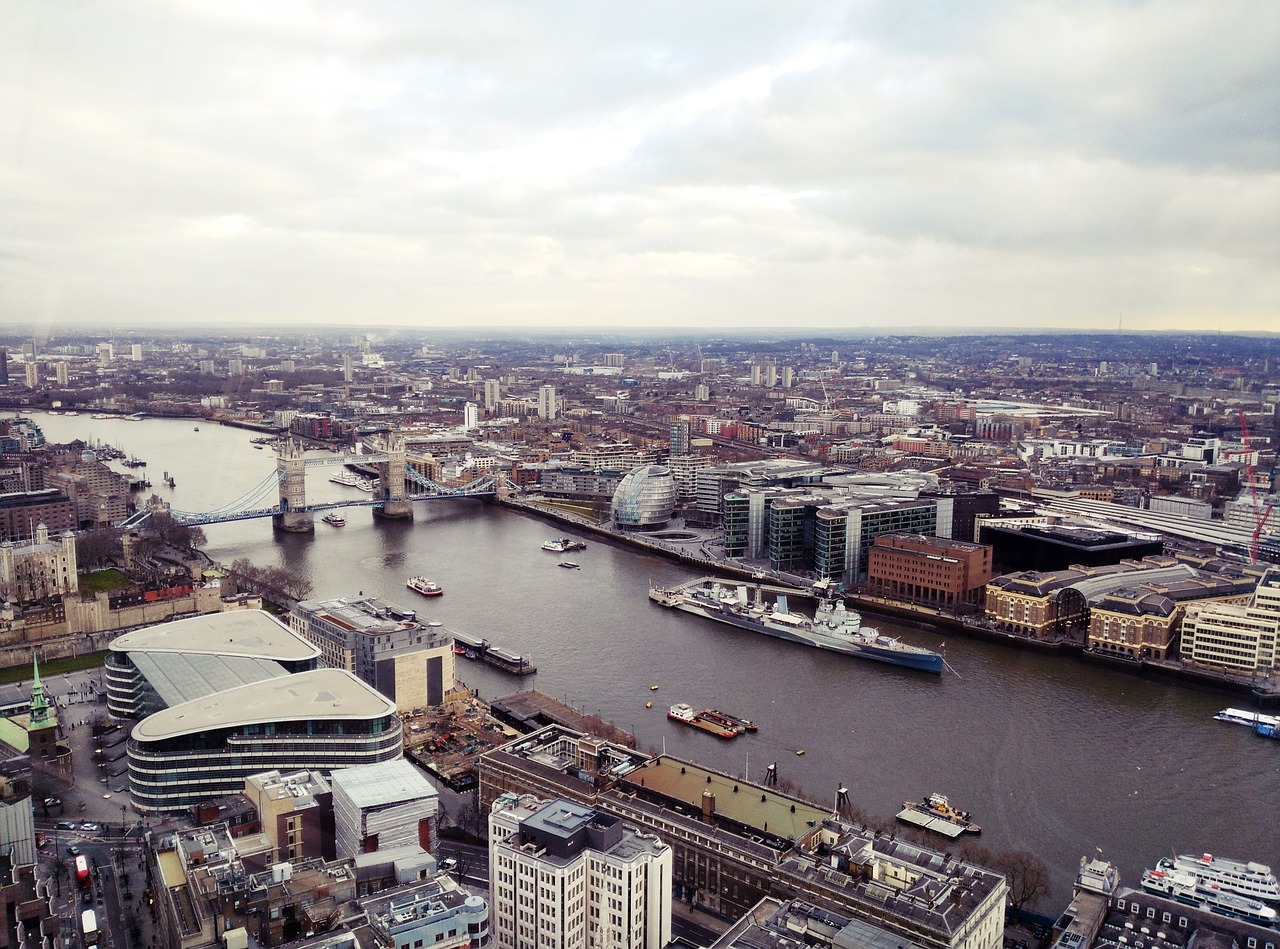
[649,576,946,672]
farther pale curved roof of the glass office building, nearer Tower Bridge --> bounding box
[109,610,320,662]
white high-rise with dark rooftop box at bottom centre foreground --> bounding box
[489,793,672,949]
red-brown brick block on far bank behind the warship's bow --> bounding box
[867,534,991,607]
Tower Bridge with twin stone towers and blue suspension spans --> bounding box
[118,434,515,533]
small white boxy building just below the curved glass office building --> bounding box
[329,758,440,857]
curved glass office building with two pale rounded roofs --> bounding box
[106,610,404,813]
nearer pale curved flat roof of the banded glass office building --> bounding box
[131,669,396,742]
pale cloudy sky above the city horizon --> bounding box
[0,0,1280,332]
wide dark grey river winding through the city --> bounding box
[40,416,1280,909]
